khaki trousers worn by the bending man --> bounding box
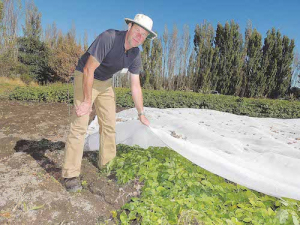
[62,71,116,178]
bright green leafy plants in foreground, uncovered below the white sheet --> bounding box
[106,145,300,225]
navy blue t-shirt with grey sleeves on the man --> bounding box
[76,29,142,81]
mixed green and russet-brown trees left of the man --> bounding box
[0,0,83,84]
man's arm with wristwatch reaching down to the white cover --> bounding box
[130,74,150,126]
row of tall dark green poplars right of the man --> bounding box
[142,21,299,98]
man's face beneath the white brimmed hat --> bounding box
[127,24,149,48]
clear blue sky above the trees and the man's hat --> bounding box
[35,0,300,51]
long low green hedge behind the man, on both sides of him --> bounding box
[9,84,300,118]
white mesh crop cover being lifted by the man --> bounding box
[85,108,300,200]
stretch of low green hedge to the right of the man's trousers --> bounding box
[117,89,300,118]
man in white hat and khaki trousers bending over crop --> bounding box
[62,14,157,192]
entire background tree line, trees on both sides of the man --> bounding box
[0,0,299,98]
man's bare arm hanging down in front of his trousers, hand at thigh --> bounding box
[76,55,100,116]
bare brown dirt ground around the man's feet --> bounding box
[0,100,136,225]
